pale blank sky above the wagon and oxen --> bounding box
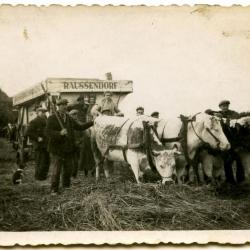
[0,6,250,117]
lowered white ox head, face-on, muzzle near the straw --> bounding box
[152,147,180,184]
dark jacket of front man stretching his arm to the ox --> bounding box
[46,113,93,157]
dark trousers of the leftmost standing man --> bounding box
[35,149,50,181]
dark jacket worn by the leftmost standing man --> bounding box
[27,116,47,150]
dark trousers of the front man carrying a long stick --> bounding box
[51,154,74,192]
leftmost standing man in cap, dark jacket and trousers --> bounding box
[27,106,49,181]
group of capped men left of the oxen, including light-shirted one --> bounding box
[27,92,123,194]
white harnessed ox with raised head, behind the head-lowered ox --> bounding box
[157,113,230,184]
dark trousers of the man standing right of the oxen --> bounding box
[223,150,245,184]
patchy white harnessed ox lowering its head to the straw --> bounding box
[91,115,179,184]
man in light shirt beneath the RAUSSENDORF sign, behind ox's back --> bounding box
[97,91,123,116]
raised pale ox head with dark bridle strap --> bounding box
[197,114,230,151]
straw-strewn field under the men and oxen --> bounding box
[0,139,250,231]
